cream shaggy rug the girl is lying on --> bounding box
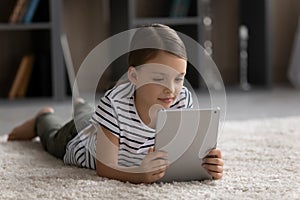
[0,117,300,199]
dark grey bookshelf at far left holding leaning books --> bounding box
[0,0,66,100]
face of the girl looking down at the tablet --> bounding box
[128,51,187,123]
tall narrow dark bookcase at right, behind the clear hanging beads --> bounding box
[240,0,273,88]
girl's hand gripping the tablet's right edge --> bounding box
[202,149,224,179]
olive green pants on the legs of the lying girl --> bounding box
[35,103,94,159]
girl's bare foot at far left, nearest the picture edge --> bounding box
[7,107,54,141]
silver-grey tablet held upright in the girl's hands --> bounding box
[155,108,220,182]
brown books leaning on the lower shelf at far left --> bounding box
[8,54,34,99]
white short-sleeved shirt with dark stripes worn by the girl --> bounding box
[64,83,193,169]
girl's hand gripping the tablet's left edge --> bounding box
[140,148,169,183]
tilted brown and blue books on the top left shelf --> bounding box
[9,0,39,24]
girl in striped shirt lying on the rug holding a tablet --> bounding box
[8,24,223,183]
